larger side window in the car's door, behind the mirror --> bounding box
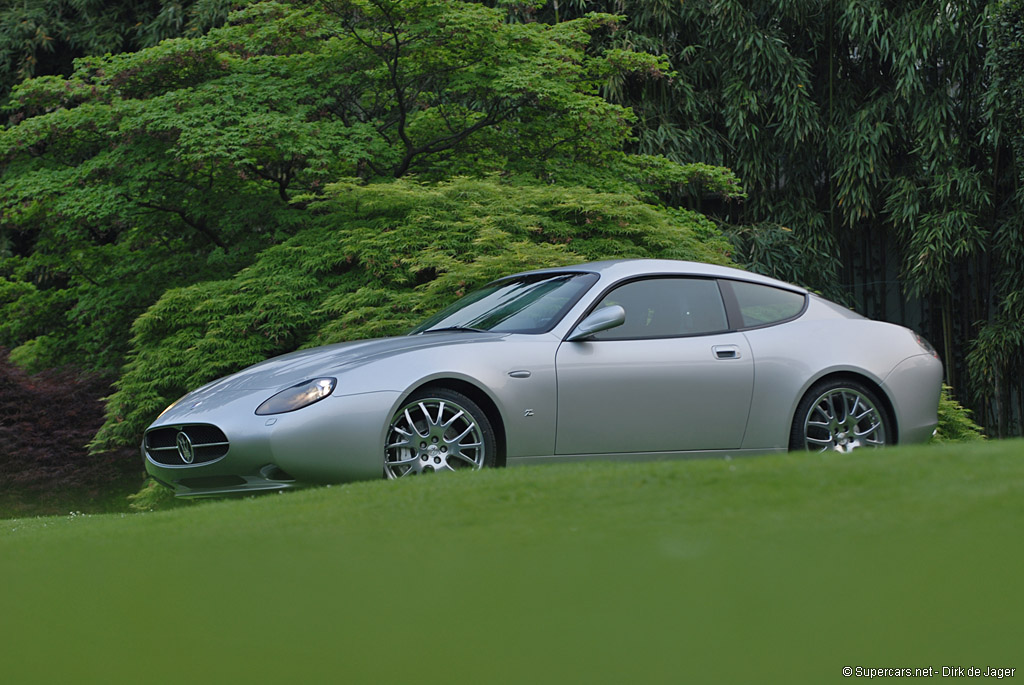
[593,279,729,340]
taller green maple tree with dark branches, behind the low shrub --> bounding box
[0,0,742,370]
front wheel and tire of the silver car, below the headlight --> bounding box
[384,388,498,478]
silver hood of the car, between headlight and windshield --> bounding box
[191,332,508,398]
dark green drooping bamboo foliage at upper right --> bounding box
[546,0,994,288]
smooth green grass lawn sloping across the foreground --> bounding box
[0,441,1024,684]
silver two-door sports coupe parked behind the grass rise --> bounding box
[142,260,942,497]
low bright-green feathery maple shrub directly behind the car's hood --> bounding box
[93,178,728,448]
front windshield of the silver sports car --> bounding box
[410,273,597,335]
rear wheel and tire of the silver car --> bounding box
[790,378,896,452]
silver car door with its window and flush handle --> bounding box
[555,276,754,455]
